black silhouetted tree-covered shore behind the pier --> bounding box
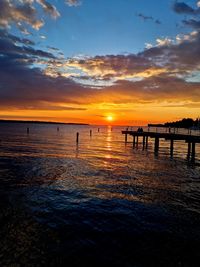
[148,118,200,129]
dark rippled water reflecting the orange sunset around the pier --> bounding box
[0,124,200,267]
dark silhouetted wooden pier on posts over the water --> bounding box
[122,130,200,162]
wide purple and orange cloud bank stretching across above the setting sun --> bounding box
[0,25,200,111]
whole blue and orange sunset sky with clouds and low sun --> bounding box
[0,0,200,125]
